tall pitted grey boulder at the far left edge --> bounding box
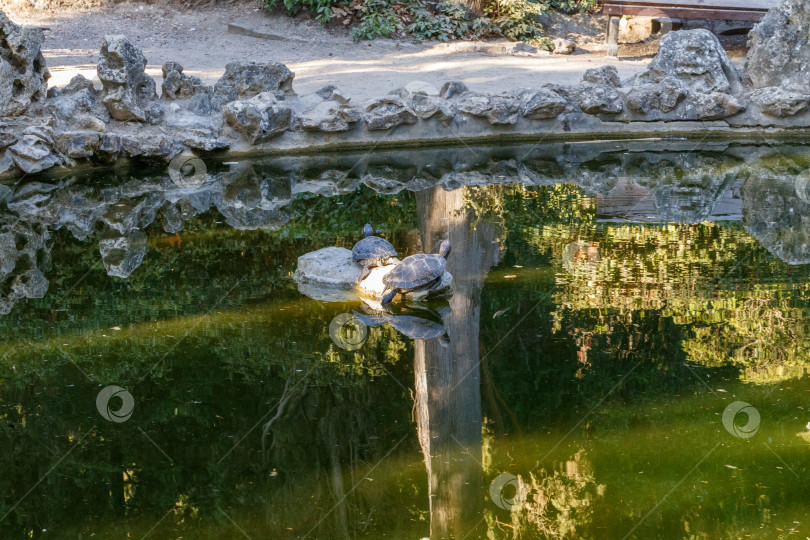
[0,11,51,117]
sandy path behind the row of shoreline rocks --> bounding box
[1,1,744,100]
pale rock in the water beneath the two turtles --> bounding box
[293,247,453,302]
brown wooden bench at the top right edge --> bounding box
[603,0,779,56]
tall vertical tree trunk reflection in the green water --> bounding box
[414,188,499,539]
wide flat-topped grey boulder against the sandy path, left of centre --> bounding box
[213,62,295,106]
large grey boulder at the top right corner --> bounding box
[745,0,810,92]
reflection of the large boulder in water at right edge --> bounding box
[742,171,810,264]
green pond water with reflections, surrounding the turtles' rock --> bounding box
[0,141,810,540]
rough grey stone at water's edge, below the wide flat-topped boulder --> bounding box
[223,92,293,144]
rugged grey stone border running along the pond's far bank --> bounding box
[0,0,810,181]
